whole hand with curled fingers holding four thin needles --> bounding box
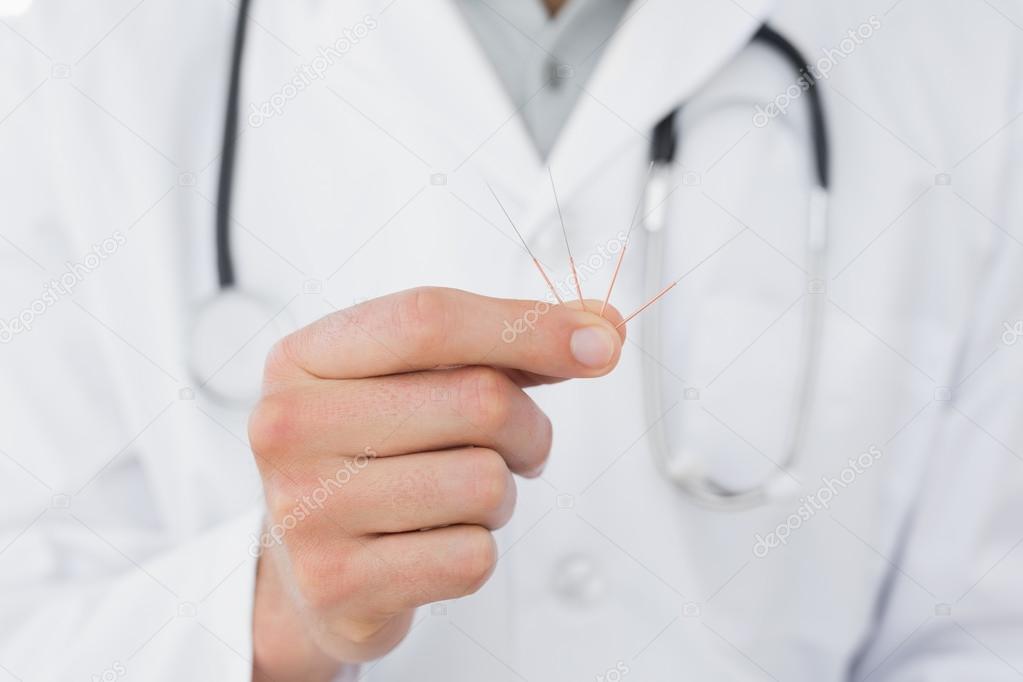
[249,288,622,682]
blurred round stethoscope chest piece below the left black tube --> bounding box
[188,287,290,408]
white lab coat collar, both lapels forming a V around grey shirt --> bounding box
[382,0,774,232]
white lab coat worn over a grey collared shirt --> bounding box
[0,0,1023,682]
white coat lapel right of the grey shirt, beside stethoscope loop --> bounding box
[525,0,774,231]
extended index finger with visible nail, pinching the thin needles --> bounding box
[273,287,623,379]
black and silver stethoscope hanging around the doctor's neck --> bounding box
[203,0,829,509]
